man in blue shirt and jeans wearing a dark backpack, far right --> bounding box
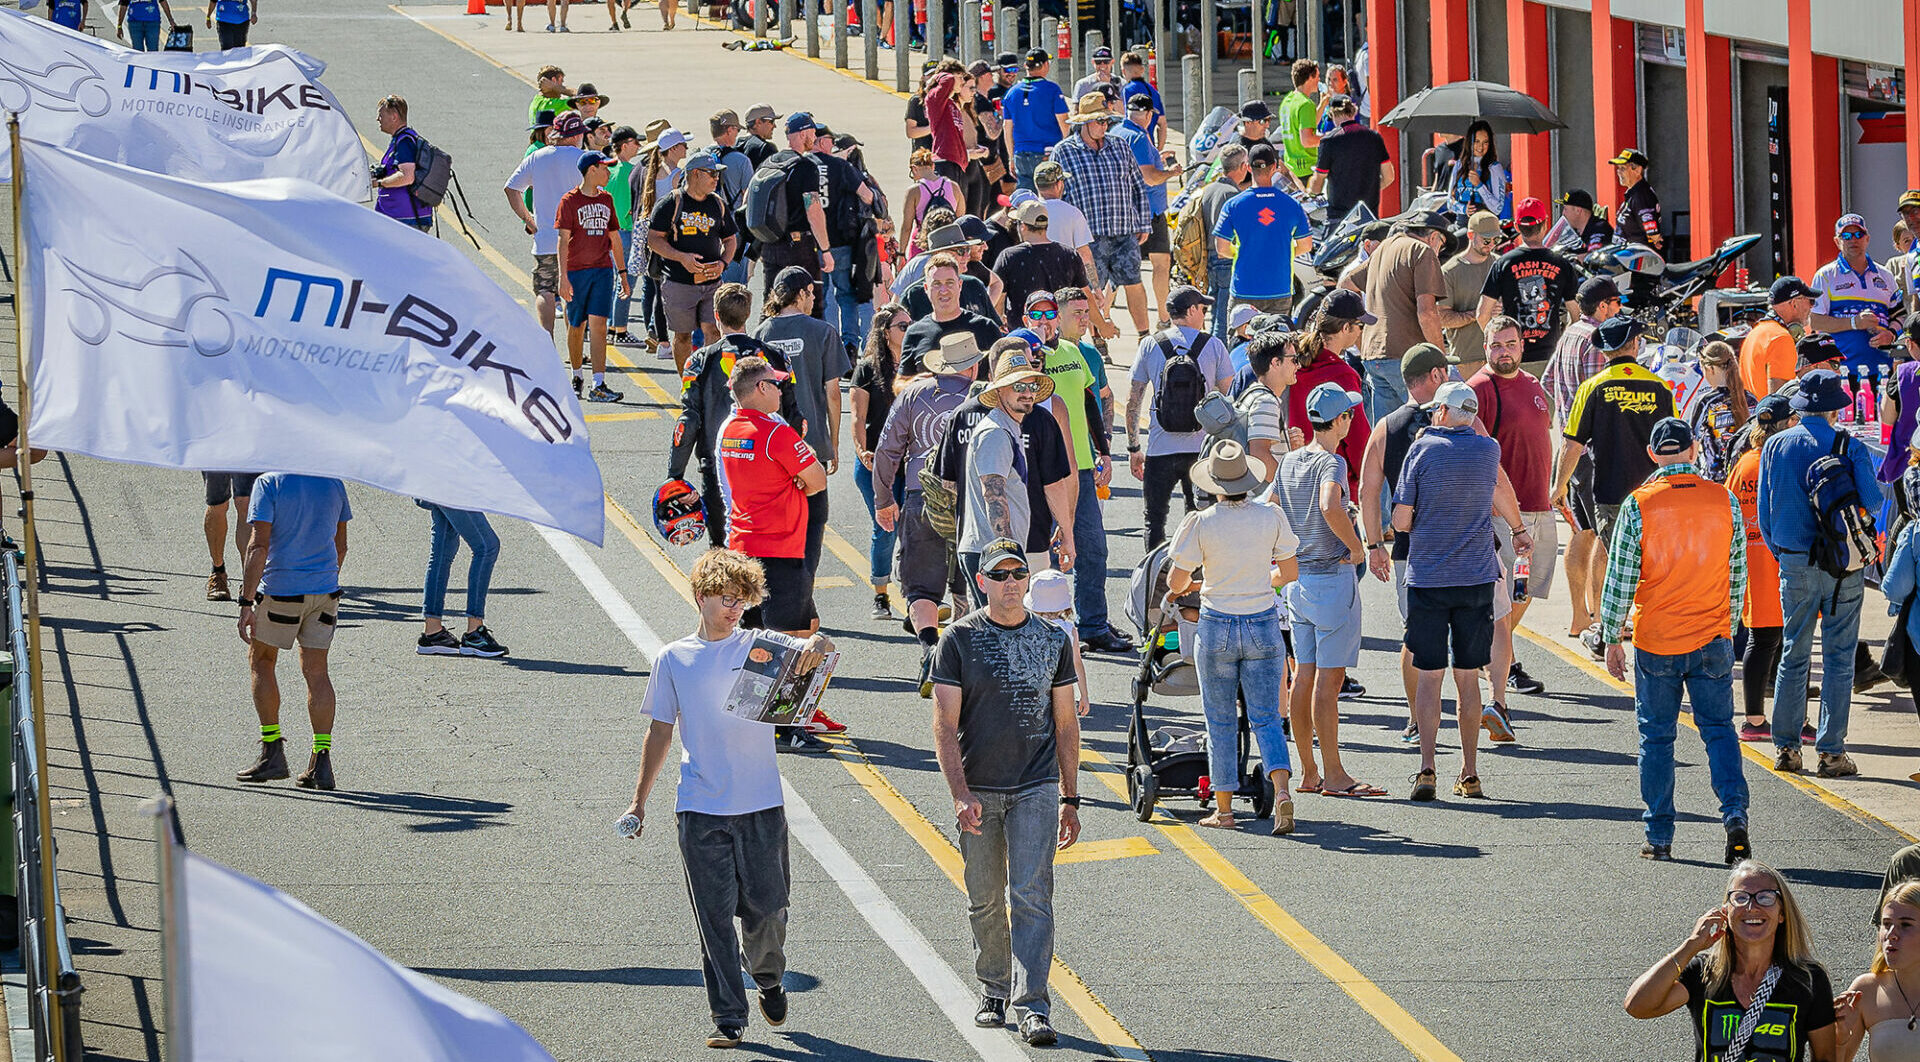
[1755,369,1878,778]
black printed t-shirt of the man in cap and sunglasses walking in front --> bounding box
[933,609,1075,793]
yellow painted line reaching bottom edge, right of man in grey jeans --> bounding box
[1081,749,1461,1062]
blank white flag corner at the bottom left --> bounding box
[180,851,553,1062]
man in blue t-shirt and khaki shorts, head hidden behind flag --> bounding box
[234,472,353,789]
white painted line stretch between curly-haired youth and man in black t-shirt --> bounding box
[780,778,1027,1062]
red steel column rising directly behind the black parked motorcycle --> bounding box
[1686,0,1734,257]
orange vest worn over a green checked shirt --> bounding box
[1634,472,1745,657]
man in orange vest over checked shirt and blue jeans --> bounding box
[1599,417,1753,866]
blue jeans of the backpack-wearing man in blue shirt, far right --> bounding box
[1772,551,1866,755]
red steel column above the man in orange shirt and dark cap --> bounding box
[1788,0,1841,277]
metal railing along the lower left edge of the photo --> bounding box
[0,542,83,1062]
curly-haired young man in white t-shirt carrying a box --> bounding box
[626,549,833,1047]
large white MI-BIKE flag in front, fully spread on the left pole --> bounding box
[21,140,605,545]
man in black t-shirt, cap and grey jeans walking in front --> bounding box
[933,538,1079,1047]
